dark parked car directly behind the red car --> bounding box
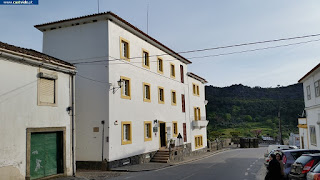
[266,149,320,178]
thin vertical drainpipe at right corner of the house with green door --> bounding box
[71,75,76,176]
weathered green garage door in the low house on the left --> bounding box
[30,132,63,179]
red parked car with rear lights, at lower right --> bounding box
[289,153,320,180]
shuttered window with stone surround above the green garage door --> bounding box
[38,72,58,106]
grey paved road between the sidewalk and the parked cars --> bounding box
[112,147,266,180]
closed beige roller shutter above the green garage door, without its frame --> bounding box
[40,78,55,104]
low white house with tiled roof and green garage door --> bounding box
[0,42,75,180]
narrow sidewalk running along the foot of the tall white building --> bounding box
[55,147,232,180]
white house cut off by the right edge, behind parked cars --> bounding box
[298,64,320,149]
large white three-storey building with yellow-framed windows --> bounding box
[35,12,208,168]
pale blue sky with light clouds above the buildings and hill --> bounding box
[0,0,320,87]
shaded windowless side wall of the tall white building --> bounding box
[43,21,109,161]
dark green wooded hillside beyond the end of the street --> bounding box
[205,84,304,138]
